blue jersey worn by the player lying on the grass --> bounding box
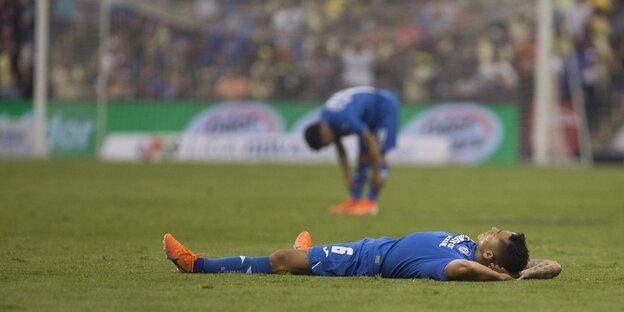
[381,232,477,281]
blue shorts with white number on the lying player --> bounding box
[308,238,380,276]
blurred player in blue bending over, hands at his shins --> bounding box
[305,87,399,215]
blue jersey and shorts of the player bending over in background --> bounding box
[321,87,399,153]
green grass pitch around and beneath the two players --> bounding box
[0,160,624,311]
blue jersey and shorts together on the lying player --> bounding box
[308,232,477,281]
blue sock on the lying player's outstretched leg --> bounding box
[193,256,273,274]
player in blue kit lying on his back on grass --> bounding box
[163,227,561,281]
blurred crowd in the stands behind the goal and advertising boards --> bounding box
[0,0,624,121]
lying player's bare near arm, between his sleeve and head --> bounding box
[444,260,514,281]
